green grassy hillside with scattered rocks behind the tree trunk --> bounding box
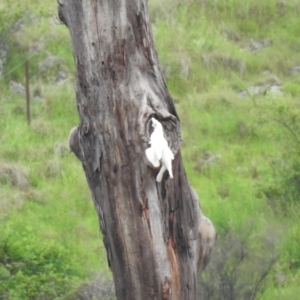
[0,0,300,300]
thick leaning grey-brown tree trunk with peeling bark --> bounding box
[58,0,215,300]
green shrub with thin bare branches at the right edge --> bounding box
[263,105,300,213]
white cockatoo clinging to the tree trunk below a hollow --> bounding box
[146,118,174,182]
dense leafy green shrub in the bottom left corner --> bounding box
[0,230,81,300]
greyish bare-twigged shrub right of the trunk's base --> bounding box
[198,226,279,300]
